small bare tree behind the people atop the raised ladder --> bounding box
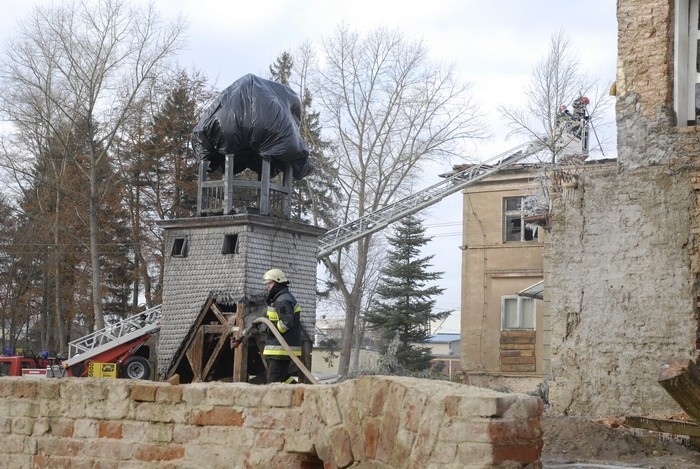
[499,30,610,163]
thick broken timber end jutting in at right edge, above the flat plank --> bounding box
[659,358,700,422]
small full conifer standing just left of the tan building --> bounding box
[365,215,451,371]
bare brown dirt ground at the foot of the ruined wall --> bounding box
[542,412,700,469]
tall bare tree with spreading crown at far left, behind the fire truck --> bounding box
[0,0,184,329]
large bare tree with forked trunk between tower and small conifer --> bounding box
[315,25,482,375]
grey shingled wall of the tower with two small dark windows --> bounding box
[158,214,325,376]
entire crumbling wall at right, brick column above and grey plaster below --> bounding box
[545,0,700,415]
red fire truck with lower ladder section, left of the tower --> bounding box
[0,305,161,379]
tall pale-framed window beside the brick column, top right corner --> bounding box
[673,0,700,127]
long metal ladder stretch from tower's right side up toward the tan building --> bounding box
[317,140,546,259]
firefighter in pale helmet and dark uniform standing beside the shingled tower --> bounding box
[263,269,301,383]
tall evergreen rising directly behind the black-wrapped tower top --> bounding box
[270,52,340,227]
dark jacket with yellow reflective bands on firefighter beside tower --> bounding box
[263,285,301,358]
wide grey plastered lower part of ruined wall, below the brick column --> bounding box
[545,167,697,416]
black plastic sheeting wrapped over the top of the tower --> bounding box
[192,74,312,179]
